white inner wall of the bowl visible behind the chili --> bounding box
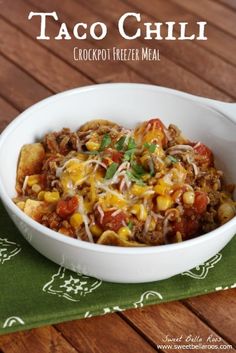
[0,84,236,198]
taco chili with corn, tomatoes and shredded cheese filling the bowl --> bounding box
[14,119,235,246]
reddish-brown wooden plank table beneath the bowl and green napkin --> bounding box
[0,0,236,353]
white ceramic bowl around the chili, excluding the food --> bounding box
[0,84,236,283]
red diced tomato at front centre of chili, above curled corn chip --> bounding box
[95,210,126,232]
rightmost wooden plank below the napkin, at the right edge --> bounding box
[184,289,236,346]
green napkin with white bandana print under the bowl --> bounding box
[0,203,236,334]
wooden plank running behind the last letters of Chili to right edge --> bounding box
[125,0,236,65]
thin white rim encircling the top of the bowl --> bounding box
[0,83,236,255]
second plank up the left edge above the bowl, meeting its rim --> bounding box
[0,55,52,110]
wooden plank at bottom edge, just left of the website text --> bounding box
[56,314,156,353]
